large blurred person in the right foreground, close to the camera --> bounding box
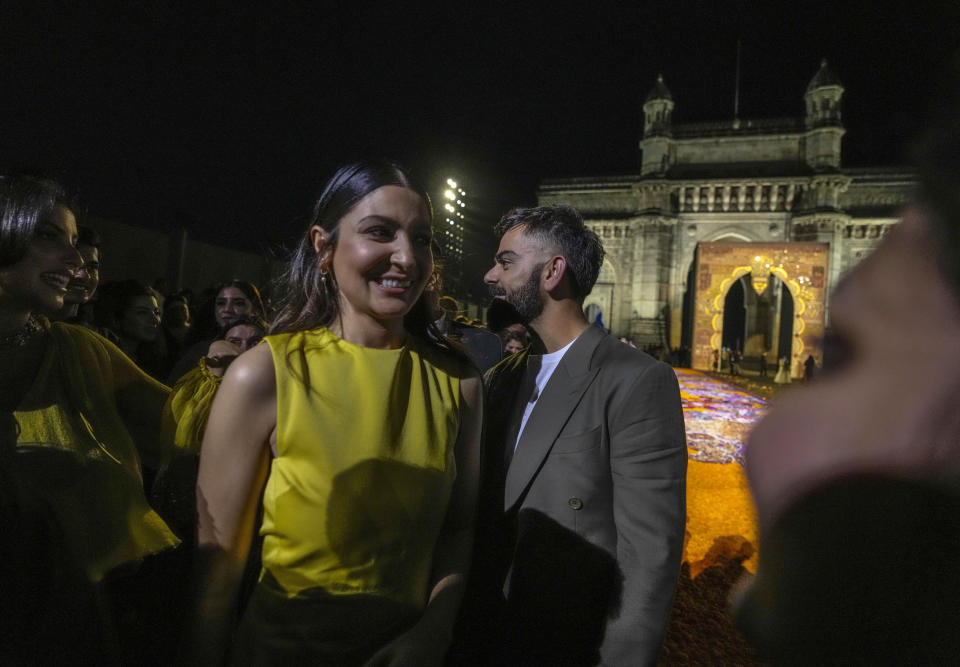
[735,73,960,665]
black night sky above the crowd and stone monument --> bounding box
[0,0,960,276]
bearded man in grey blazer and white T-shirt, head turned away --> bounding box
[475,206,687,665]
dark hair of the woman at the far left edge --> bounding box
[0,174,74,266]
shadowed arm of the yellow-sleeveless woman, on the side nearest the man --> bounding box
[368,375,483,667]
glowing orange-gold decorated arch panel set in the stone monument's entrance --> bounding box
[692,242,830,377]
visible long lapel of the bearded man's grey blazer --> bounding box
[503,326,605,510]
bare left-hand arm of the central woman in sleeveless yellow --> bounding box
[188,345,277,664]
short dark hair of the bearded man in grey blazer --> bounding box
[496,204,604,302]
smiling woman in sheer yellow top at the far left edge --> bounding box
[0,176,178,664]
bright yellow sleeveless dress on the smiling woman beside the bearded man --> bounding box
[236,329,460,664]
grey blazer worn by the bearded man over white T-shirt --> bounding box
[478,326,687,666]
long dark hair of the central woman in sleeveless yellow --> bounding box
[270,159,465,368]
